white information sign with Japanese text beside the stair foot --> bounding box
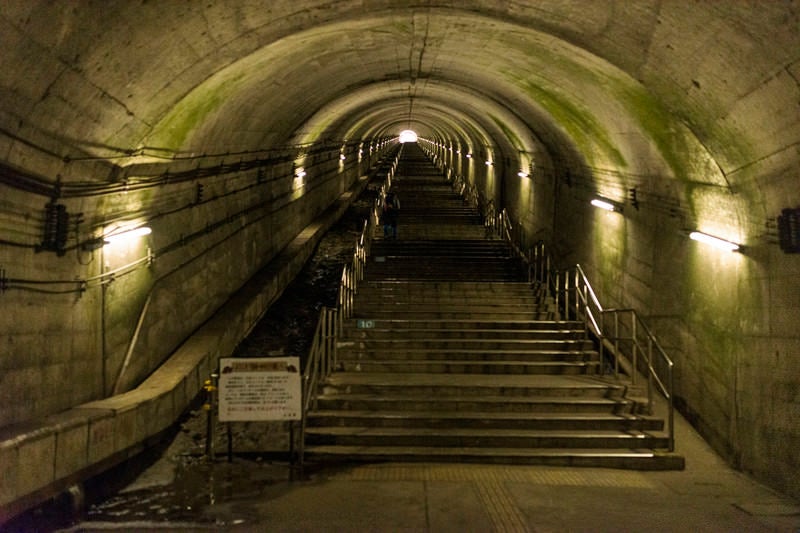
[219,357,303,422]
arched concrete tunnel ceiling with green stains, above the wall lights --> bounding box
[0,0,800,219]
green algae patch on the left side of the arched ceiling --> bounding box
[149,72,242,150]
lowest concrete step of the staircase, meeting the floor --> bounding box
[305,445,684,470]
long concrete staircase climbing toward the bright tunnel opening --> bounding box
[305,144,683,469]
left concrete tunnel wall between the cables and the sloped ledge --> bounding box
[0,147,378,426]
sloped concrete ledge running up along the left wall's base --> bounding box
[0,176,369,524]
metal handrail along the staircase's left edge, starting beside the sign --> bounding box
[298,151,400,469]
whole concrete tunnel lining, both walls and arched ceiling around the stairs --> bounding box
[0,0,800,512]
